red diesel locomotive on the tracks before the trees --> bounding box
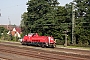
[21,33,56,48]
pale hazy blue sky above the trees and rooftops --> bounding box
[0,0,73,25]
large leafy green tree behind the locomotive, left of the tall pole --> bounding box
[21,0,71,40]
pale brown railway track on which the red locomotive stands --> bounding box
[3,42,90,55]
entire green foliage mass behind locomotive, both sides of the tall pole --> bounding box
[21,0,90,45]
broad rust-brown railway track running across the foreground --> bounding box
[0,44,90,60]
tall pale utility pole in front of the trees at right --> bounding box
[72,3,76,44]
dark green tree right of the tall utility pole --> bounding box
[74,0,90,45]
